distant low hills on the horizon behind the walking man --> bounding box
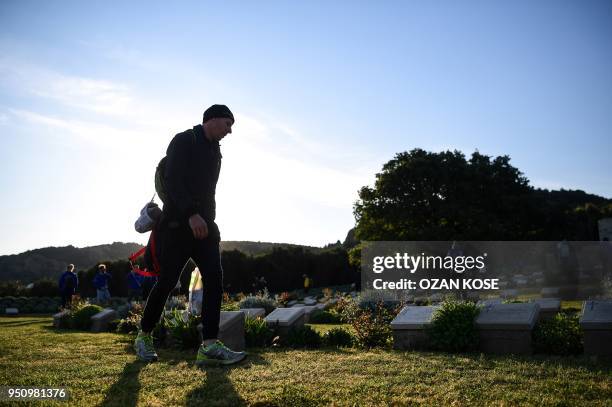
[0,241,321,283]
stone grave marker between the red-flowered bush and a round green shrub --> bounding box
[391,305,439,350]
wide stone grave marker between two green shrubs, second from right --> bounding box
[476,303,540,355]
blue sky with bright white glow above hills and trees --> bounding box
[0,0,612,254]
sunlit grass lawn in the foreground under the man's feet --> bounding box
[0,316,612,407]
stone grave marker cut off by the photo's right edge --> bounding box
[580,300,612,356]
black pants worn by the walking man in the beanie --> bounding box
[141,220,223,340]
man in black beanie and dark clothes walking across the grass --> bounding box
[134,105,246,365]
